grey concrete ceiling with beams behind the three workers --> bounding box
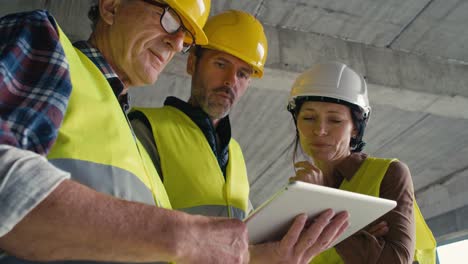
[0,0,468,243]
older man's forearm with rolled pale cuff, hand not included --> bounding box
[0,145,186,261]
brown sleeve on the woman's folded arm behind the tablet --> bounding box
[335,162,416,264]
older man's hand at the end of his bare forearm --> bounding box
[176,215,249,264]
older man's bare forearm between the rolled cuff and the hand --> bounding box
[0,180,186,262]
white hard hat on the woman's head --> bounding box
[288,62,371,119]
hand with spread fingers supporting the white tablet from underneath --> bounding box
[250,209,348,264]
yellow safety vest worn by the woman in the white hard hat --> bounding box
[310,157,436,264]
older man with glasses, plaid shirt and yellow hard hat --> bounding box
[0,0,256,263]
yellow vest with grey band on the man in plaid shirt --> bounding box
[48,28,171,208]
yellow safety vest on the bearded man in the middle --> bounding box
[136,106,249,219]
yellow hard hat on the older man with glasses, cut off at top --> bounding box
[165,0,211,45]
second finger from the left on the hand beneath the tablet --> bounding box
[296,209,335,255]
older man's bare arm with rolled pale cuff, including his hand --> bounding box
[0,145,248,264]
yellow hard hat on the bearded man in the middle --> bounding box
[203,10,268,78]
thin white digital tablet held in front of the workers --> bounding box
[244,181,396,246]
